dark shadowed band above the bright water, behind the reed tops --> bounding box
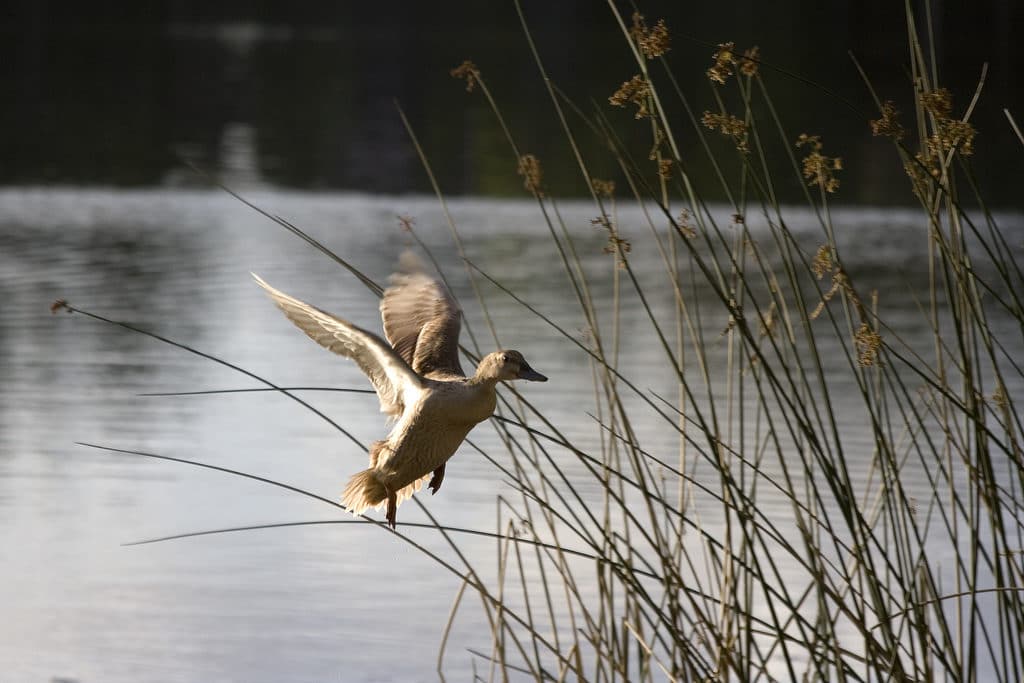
[0,0,1024,206]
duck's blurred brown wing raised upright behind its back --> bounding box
[381,252,465,377]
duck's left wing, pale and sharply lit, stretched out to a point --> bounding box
[252,273,423,418]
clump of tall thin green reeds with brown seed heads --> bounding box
[417,3,1024,681]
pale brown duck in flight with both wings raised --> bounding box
[252,252,548,529]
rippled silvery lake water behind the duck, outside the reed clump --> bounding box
[0,188,1024,683]
